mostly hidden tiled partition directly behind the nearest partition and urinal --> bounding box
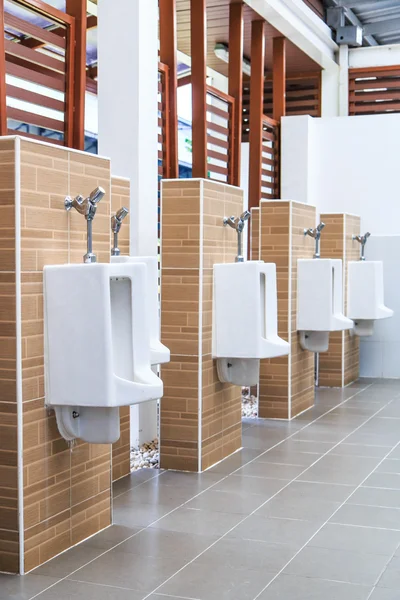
[111,177,131,481]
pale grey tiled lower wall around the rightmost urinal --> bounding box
[360,235,400,378]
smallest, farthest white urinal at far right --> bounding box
[347,260,393,337]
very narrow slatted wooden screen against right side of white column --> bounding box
[158,63,170,181]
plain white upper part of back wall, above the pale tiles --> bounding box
[282,114,400,235]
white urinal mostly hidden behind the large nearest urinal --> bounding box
[111,256,171,365]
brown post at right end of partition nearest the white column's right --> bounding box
[228,0,243,186]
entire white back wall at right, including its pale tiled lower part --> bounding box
[282,114,400,377]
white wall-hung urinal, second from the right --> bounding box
[297,258,353,352]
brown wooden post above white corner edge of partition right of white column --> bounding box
[190,0,208,179]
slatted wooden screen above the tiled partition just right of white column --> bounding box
[207,86,235,184]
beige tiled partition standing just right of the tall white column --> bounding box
[160,179,243,471]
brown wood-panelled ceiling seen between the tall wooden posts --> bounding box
[177,0,320,75]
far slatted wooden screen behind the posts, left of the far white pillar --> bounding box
[243,72,321,142]
